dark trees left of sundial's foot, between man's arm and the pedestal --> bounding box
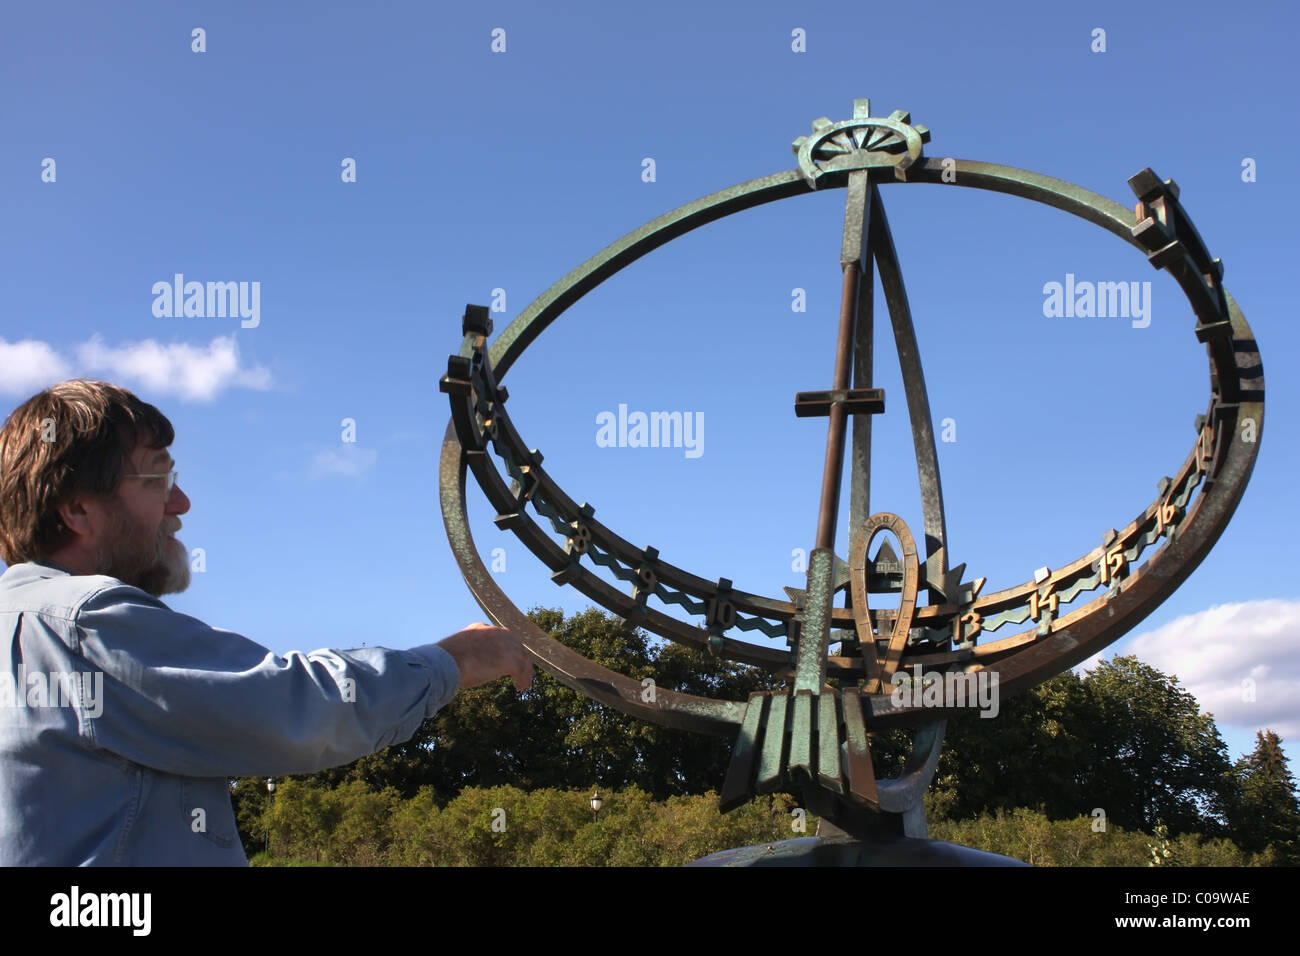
[289,609,776,804]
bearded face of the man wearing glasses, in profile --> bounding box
[95,445,190,597]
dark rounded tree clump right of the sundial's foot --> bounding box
[904,657,1236,835]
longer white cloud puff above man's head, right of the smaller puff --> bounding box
[77,336,270,402]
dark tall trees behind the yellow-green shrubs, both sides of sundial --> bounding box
[235,609,1253,851]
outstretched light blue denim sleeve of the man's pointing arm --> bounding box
[74,584,460,777]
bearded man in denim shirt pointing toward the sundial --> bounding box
[0,381,533,865]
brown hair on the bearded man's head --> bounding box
[0,380,176,564]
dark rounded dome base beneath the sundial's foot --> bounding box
[686,836,1028,866]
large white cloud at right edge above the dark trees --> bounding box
[1086,598,1300,744]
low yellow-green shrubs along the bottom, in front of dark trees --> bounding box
[244,780,1277,866]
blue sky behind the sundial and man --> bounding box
[0,0,1300,760]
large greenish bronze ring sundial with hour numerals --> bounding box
[441,99,1264,836]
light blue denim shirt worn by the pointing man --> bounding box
[0,562,460,866]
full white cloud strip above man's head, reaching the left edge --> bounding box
[0,336,270,402]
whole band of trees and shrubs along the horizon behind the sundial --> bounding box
[233,609,1300,865]
